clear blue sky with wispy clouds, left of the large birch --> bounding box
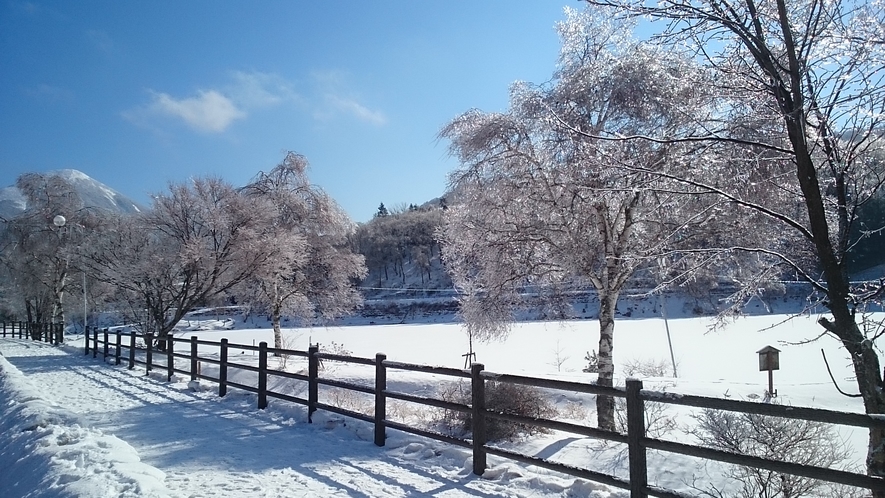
[0,0,582,221]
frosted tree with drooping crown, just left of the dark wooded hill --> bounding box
[243,152,366,348]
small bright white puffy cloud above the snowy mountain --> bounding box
[139,90,246,133]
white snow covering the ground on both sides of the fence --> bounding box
[0,315,867,498]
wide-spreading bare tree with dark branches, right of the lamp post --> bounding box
[85,178,280,348]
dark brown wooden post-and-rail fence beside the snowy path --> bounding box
[4,328,885,498]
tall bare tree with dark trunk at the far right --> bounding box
[587,0,885,478]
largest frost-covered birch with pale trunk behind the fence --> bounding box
[441,9,715,430]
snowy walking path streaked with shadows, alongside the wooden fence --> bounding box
[0,339,621,498]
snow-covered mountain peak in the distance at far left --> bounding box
[0,169,145,218]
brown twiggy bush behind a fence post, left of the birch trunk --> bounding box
[438,381,557,441]
